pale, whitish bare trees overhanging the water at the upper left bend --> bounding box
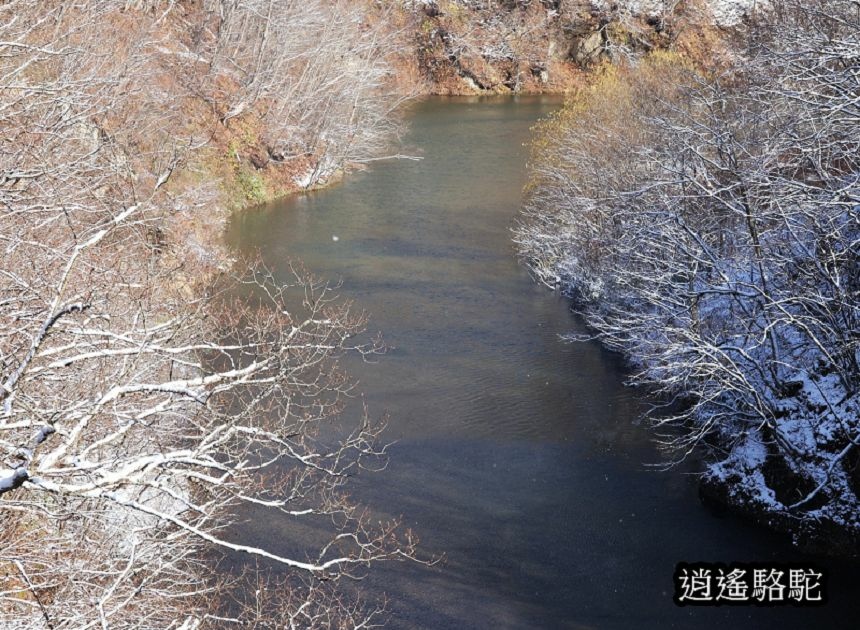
[207,0,409,188]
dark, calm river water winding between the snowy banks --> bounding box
[228,98,860,629]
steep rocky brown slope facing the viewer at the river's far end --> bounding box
[390,0,761,94]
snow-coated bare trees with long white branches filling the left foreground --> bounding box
[0,0,420,630]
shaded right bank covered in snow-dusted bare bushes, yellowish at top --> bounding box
[516,2,860,557]
